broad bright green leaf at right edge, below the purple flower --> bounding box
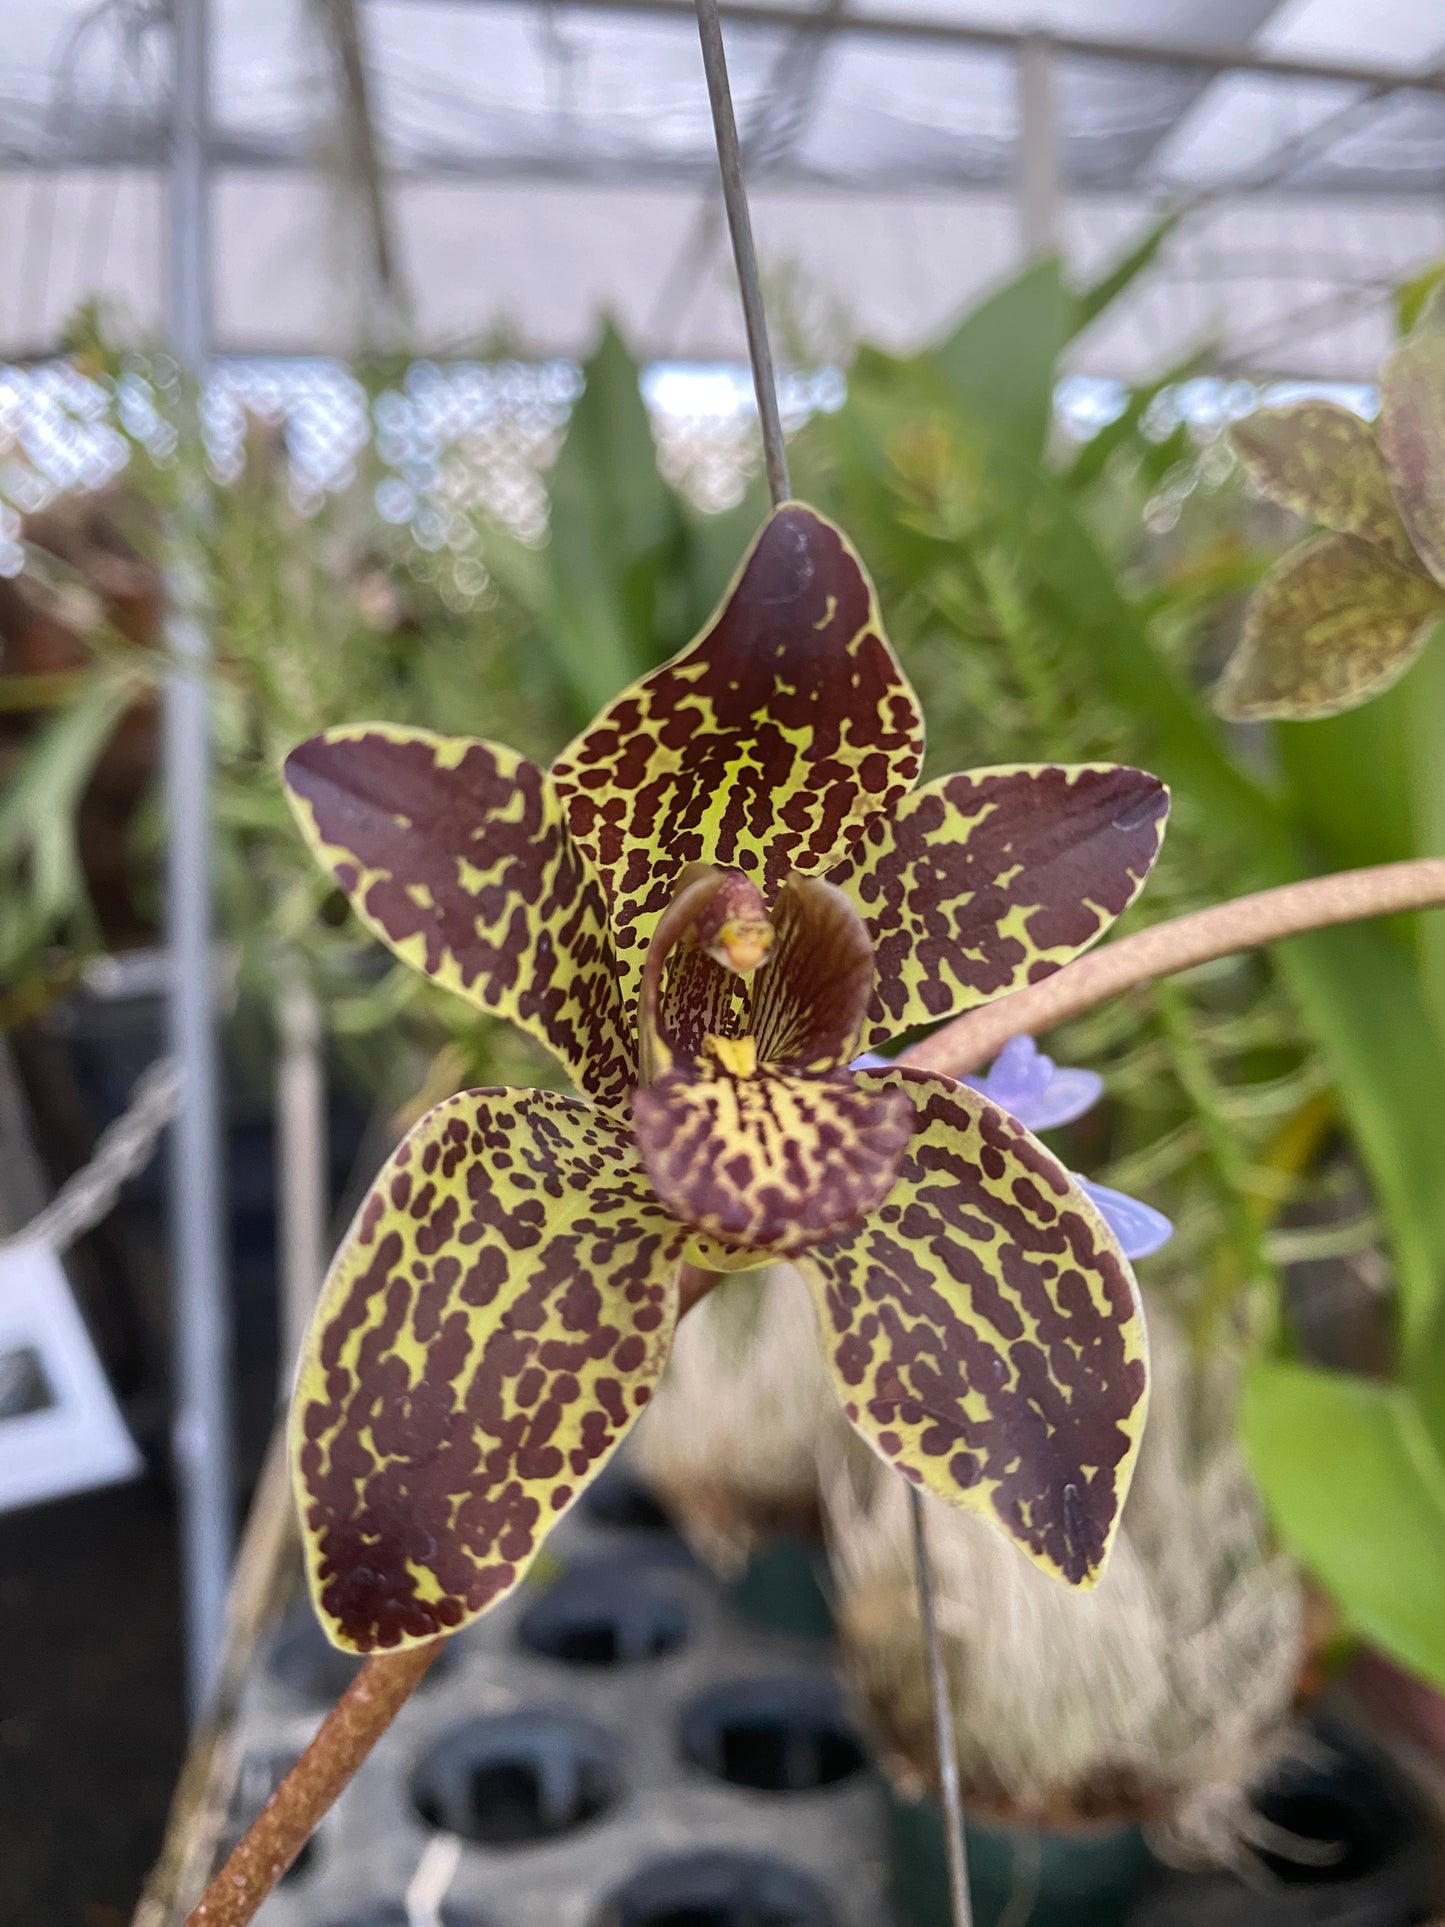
[1241,1362,1445,1688]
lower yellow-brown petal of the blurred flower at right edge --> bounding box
[1214,536,1445,721]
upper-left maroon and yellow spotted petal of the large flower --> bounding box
[285,723,634,1104]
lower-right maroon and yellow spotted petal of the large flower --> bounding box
[798,1071,1146,1586]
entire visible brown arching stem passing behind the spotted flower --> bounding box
[187,858,1445,1927]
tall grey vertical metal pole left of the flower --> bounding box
[164,0,235,1719]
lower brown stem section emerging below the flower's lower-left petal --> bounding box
[187,1640,443,1927]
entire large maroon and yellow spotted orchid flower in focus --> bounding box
[287,503,1168,1651]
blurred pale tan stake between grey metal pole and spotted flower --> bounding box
[276,979,328,1399]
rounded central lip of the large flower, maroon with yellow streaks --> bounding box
[632,1071,913,1256]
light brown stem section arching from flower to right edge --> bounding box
[902,858,1445,1077]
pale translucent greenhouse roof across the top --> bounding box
[0,0,1445,380]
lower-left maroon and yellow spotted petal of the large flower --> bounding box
[291,1091,686,1653]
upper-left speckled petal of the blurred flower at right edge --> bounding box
[1229,401,1420,568]
